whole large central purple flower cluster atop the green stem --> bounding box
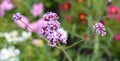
[38,12,67,47]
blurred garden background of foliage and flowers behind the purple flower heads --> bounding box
[0,0,120,61]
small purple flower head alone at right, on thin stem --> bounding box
[93,22,106,36]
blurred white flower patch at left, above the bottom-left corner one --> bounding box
[4,30,31,43]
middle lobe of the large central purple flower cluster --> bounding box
[39,20,60,37]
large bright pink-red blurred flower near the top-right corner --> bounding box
[107,5,119,19]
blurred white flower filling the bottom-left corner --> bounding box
[0,46,20,61]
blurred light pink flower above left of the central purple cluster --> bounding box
[30,3,43,17]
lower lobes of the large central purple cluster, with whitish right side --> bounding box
[45,28,67,47]
